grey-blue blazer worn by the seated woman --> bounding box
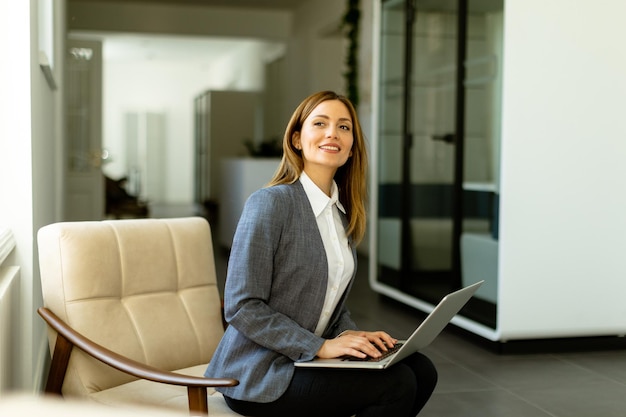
[205,181,357,402]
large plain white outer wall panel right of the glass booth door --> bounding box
[498,0,626,338]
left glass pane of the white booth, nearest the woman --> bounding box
[378,1,459,301]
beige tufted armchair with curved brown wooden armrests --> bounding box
[38,217,238,417]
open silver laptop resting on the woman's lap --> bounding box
[294,281,484,369]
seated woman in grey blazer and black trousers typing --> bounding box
[205,91,437,417]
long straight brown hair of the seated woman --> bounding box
[268,91,367,245]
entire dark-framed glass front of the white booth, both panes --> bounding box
[375,0,502,326]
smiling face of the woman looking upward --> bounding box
[292,100,354,174]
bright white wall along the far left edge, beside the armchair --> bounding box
[0,0,65,391]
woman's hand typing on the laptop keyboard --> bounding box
[317,330,398,359]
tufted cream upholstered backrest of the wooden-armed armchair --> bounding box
[38,217,224,396]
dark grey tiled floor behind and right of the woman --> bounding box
[156,207,626,417]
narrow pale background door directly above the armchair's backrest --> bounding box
[64,39,106,221]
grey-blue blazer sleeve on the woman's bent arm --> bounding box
[224,187,324,361]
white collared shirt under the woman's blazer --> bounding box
[300,172,354,336]
